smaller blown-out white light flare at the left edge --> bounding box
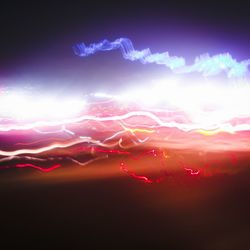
[0,91,86,122]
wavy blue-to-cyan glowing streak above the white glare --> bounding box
[73,38,250,78]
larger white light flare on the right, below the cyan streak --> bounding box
[114,78,250,128]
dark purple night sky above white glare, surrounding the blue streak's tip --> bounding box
[0,1,250,92]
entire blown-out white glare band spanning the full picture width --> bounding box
[0,77,250,135]
